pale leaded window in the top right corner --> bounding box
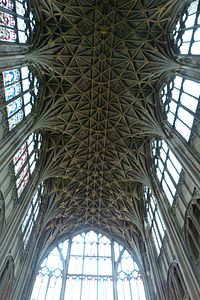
[172,0,200,55]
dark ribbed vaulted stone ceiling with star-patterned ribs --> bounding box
[30,0,180,247]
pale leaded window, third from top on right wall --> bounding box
[152,140,182,205]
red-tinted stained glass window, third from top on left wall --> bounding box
[13,133,41,197]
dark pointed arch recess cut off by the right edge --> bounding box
[184,195,200,270]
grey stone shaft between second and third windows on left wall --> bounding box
[0,116,34,173]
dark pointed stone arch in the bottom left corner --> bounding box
[0,255,14,300]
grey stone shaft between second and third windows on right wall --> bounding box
[166,123,200,191]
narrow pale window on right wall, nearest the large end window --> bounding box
[144,186,166,255]
